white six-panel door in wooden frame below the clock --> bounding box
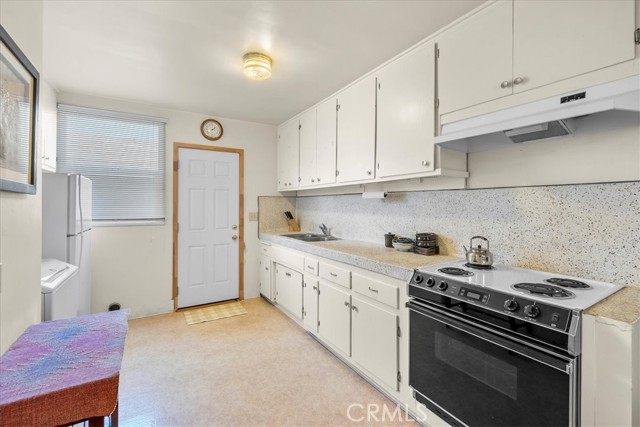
[178,148,240,308]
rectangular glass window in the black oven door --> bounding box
[435,332,518,400]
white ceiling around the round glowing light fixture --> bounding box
[43,0,482,124]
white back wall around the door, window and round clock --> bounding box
[58,93,278,317]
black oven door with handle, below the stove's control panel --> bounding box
[408,301,578,426]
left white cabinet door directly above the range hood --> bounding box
[437,1,512,114]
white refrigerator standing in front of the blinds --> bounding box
[42,173,92,315]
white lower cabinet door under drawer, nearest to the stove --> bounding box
[351,295,399,390]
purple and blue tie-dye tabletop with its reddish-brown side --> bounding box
[0,310,129,426]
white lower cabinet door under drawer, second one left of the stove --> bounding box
[318,282,351,356]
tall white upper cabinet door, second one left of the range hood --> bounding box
[337,76,376,183]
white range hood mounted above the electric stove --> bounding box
[435,75,640,152]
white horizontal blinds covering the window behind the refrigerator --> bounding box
[57,104,165,221]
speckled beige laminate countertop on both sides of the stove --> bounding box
[259,232,640,324]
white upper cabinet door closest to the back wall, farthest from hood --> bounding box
[277,120,300,191]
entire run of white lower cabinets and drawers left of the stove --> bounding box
[260,245,404,404]
